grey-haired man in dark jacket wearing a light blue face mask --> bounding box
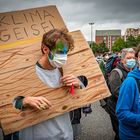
[107,48,136,140]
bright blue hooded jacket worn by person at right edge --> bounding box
[116,68,140,140]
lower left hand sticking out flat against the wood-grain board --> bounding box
[23,96,52,110]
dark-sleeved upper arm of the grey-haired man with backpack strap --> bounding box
[109,70,122,97]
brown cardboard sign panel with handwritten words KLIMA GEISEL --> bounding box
[0,6,65,44]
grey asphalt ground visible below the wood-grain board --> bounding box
[0,102,114,140]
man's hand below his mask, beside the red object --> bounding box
[60,74,80,88]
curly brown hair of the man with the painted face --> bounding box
[41,29,74,53]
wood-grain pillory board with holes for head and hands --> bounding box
[0,31,110,134]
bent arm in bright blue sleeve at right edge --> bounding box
[116,78,140,126]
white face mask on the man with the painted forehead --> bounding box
[49,54,67,68]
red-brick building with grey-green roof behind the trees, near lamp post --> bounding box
[95,30,121,51]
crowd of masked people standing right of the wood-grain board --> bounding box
[97,45,140,140]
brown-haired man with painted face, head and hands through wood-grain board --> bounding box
[14,29,86,140]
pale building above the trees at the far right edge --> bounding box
[124,28,140,41]
